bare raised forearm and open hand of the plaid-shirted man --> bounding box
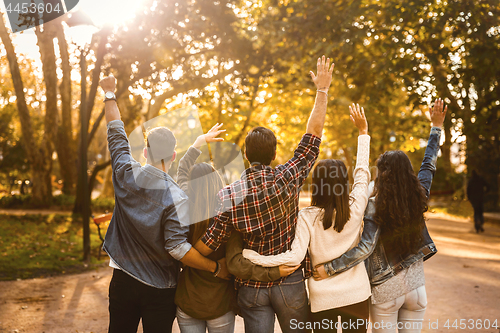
[306,56,335,138]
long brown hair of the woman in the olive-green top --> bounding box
[188,163,224,244]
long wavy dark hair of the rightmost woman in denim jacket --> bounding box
[374,150,427,253]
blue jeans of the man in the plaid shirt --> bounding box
[238,270,309,333]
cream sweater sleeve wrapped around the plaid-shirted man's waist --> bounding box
[243,213,311,267]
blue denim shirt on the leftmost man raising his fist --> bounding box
[103,120,191,289]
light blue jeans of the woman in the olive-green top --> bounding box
[177,307,235,333]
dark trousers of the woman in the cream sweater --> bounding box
[312,298,370,333]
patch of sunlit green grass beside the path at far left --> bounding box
[0,214,107,281]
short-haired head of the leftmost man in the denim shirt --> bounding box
[146,127,177,165]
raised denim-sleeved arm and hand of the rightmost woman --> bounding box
[418,99,448,197]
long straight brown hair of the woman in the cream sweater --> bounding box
[311,160,351,232]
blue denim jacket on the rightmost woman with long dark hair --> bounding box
[324,127,441,285]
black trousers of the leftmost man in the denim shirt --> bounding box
[108,269,176,333]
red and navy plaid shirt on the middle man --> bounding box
[202,134,321,288]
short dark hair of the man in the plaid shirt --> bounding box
[245,126,277,165]
